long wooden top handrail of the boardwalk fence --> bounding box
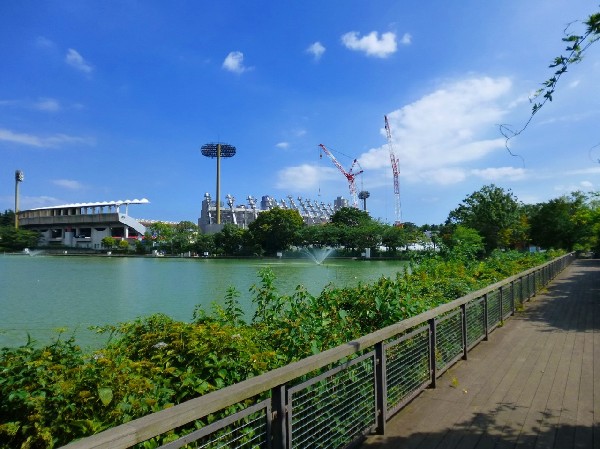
[64,253,574,449]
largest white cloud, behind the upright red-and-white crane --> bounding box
[359,77,516,184]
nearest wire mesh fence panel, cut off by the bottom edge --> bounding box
[159,399,271,449]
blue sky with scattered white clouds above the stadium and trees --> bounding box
[0,0,600,224]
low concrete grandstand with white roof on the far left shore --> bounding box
[18,198,149,249]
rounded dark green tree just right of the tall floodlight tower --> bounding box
[248,208,304,255]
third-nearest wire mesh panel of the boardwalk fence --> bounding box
[385,326,431,416]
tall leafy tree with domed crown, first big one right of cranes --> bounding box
[447,184,521,252]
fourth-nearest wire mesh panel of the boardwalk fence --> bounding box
[435,310,463,374]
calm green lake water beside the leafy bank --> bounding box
[0,255,406,347]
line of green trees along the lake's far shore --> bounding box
[0,184,600,258]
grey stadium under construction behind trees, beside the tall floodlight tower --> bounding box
[198,193,349,234]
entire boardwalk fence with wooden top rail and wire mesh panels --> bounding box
[66,254,574,449]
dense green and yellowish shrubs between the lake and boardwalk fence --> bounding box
[0,247,556,448]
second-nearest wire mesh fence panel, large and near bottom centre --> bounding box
[288,352,376,449]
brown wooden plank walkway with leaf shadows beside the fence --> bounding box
[361,260,600,449]
